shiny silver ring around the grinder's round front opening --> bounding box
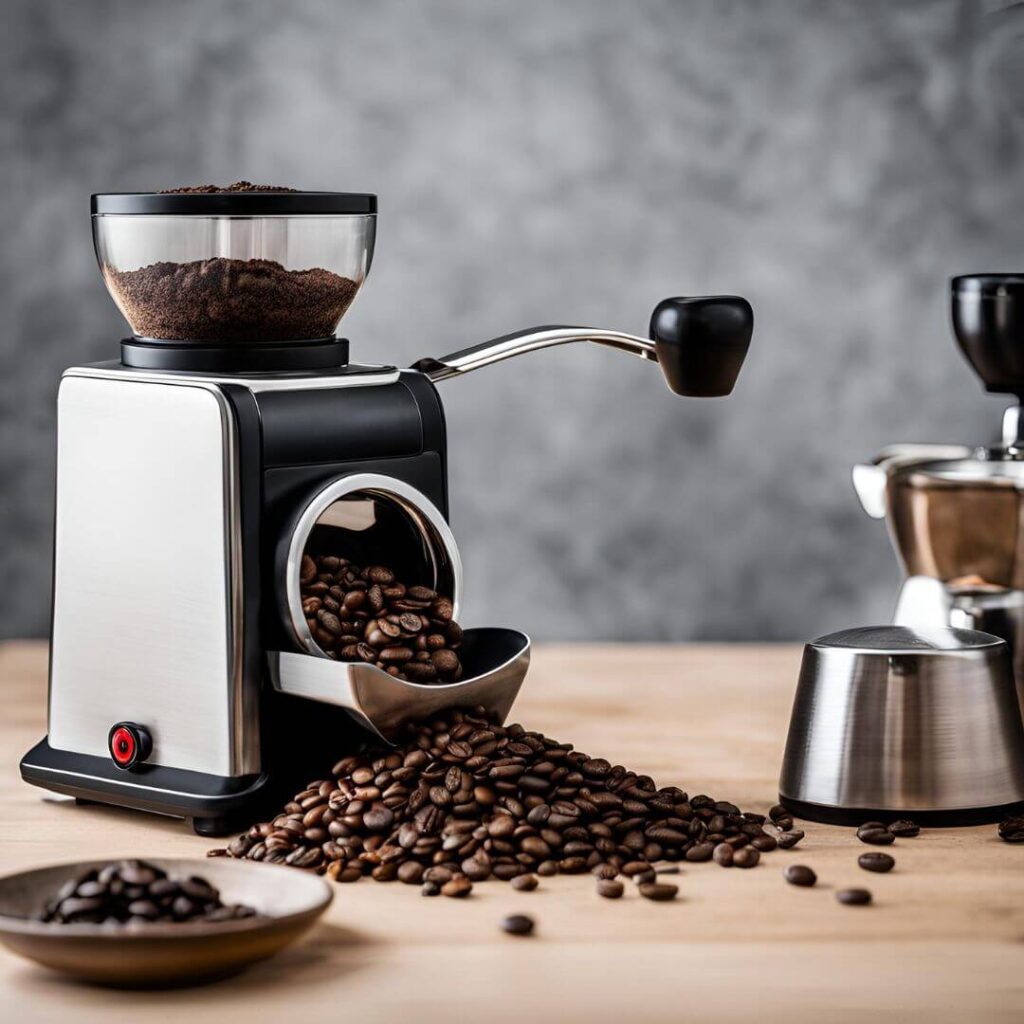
[285,473,462,655]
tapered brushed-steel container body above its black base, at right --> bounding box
[779,627,1024,811]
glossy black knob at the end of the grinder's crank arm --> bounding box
[650,295,754,398]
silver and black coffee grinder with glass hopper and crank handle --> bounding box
[22,190,753,835]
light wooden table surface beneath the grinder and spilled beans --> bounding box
[0,643,1024,1024]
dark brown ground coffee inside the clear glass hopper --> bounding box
[103,257,358,342]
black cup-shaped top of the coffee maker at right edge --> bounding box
[951,273,1024,397]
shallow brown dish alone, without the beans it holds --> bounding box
[0,857,333,988]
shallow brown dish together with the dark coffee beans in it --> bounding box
[0,857,332,987]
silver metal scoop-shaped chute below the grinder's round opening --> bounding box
[267,627,530,743]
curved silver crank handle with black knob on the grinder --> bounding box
[413,295,754,396]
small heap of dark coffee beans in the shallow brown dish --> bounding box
[35,860,256,925]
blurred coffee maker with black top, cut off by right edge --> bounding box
[853,273,1024,706]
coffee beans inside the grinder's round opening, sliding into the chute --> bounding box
[299,555,462,683]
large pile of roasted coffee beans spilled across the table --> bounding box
[211,710,793,900]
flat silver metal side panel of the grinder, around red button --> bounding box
[49,370,259,775]
